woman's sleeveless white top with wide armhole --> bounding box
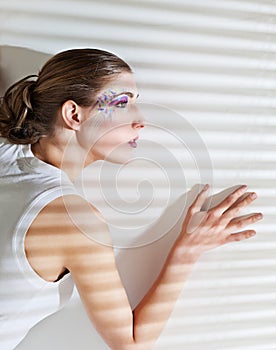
[0,138,79,350]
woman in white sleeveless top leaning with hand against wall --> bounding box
[0,49,262,350]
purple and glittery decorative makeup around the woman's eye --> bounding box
[97,89,129,120]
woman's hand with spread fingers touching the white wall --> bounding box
[180,185,263,256]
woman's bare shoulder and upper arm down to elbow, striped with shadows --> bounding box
[25,195,133,350]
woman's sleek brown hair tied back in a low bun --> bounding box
[0,49,131,144]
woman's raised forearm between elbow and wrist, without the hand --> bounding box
[130,241,198,350]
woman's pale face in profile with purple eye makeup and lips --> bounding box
[80,72,144,163]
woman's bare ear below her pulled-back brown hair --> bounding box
[61,100,83,130]
